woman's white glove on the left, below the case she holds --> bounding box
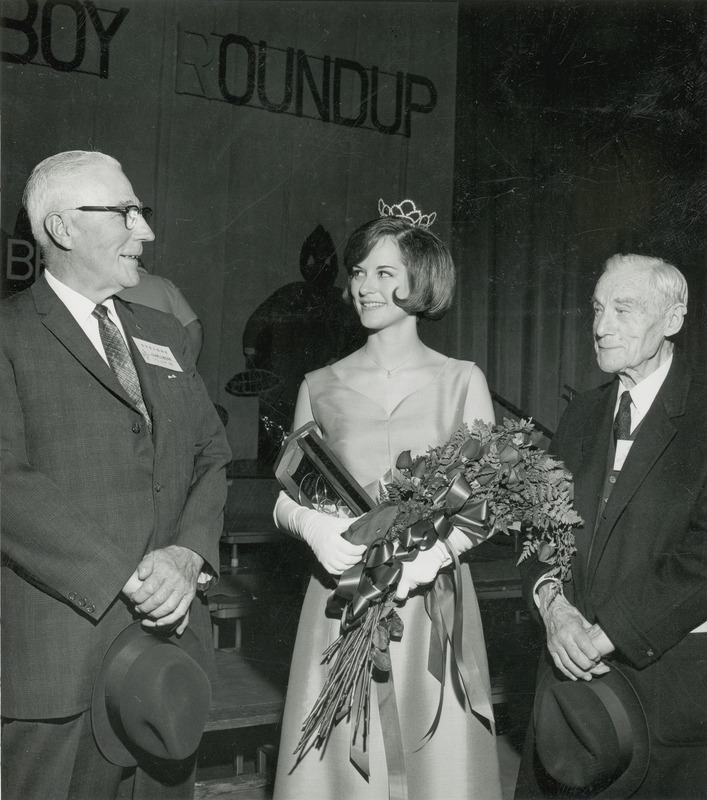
[273,492,366,575]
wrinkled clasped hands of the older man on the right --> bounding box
[539,587,613,681]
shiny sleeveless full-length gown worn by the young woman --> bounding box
[274,358,501,800]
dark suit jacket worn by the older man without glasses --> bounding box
[524,352,707,796]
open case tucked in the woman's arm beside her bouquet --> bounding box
[275,422,375,517]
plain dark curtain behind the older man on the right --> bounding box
[451,2,707,438]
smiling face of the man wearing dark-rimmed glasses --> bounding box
[57,163,155,303]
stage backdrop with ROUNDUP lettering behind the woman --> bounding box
[1,0,457,458]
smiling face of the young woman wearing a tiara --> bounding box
[349,236,410,330]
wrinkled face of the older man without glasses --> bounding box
[593,267,684,384]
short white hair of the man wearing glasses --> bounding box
[22,150,122,249]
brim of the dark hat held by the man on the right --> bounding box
[534,662,650,800]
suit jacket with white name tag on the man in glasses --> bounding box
[0,277,230,718]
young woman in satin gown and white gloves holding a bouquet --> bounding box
[274,207,501,800]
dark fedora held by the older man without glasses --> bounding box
[533,663,650,800]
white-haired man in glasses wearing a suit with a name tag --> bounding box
[0,151,230,800]
